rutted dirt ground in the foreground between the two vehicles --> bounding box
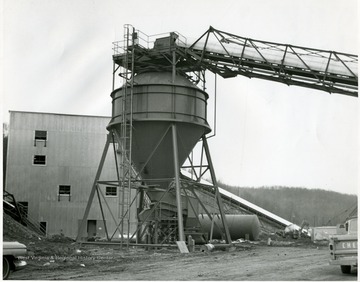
[10,241,357,281]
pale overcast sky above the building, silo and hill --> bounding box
[1,0,358,194]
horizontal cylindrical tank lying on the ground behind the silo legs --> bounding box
[199,214,260,241]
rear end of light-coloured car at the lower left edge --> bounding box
[3,242,27,280]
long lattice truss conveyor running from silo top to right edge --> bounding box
[113,27,358,97]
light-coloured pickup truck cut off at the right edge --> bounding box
[329,216,358,274]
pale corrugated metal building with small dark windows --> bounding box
[5,111,134,238]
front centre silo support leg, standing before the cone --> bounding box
[172,124,185,246]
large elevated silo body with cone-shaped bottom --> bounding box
[108,72,211,193]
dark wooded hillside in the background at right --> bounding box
[219,183,357,226]
